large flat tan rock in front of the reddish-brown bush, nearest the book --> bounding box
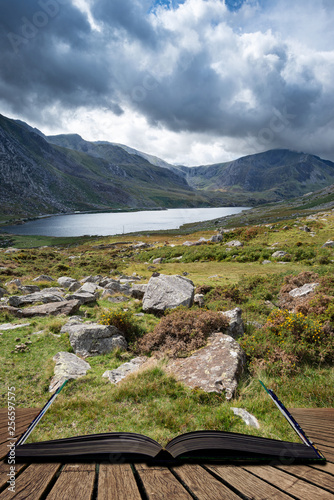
[167,333,246,400]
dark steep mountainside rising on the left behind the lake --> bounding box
[0,115,210,216]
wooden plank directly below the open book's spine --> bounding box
[135,464,192,500]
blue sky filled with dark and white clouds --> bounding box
[0,0,334,166]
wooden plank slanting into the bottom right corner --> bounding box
[244,465,334,500]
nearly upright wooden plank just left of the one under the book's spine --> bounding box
[97,464,142,500]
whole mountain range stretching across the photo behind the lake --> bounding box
[0,115,334,217]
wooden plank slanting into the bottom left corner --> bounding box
[0,464,61,500]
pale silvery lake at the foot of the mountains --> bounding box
[2,207,248,236]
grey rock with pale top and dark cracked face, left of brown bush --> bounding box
[62,323,127,357]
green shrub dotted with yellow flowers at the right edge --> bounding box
[240,309,334,375]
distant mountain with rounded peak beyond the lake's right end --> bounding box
[181,149,334,201]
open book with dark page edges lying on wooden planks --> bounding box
[15,387,325,464]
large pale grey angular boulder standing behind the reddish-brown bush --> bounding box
[143,274,195,313]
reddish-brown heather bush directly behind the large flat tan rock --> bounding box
[138,308,228,356]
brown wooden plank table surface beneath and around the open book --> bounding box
[0,408,334,500]
